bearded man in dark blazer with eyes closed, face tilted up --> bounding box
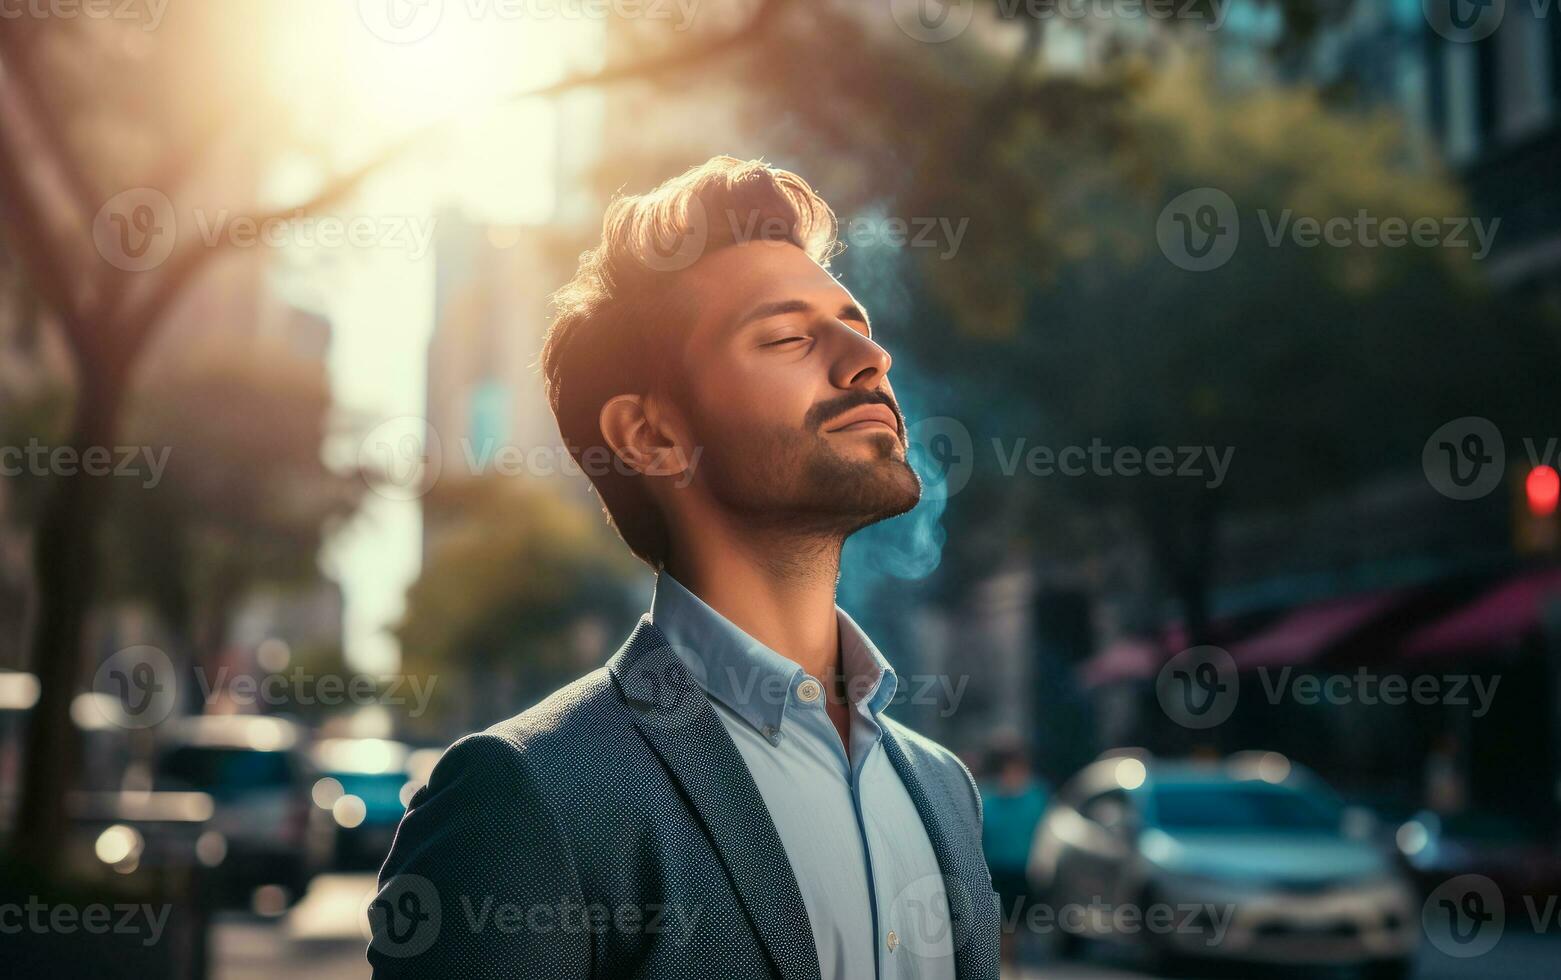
[368,156,997,980]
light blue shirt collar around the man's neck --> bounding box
[651,570,898,738]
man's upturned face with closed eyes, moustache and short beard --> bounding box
[673,240,921,535]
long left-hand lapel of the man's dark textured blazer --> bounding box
[607,618,830,980]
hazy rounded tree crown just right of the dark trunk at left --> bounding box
[105,342,365,692]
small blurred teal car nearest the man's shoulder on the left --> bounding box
[311,738,415,871]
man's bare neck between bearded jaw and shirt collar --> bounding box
[667,523,843,679]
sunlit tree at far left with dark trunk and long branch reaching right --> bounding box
[0,0,785,868]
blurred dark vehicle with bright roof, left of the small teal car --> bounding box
[153,715,331,897]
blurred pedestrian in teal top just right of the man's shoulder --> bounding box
[980,744,1051,966]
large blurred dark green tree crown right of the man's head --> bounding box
[910,59,1555,509]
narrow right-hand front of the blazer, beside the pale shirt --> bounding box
[884,726,997,980]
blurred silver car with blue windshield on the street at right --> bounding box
[1030,752,1419,977]
